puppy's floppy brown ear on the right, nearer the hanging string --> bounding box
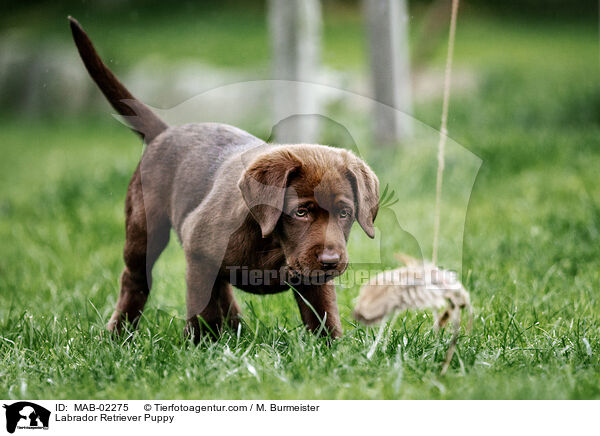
[348,158,379,239]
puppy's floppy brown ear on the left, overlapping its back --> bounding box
[238,150,302,238]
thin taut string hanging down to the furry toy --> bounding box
[431,0,459,265]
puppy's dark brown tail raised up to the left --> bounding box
[68,16,168,144]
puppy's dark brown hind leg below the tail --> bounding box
[107,167,170,332]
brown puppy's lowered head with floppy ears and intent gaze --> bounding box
[239,145,379,279]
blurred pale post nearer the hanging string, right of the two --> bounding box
[364,0,412,144]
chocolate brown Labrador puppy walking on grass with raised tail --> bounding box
[69,17,379,341]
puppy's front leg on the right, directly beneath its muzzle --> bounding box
[294,283,342,338]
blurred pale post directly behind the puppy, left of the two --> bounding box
[269,0,322,142]
